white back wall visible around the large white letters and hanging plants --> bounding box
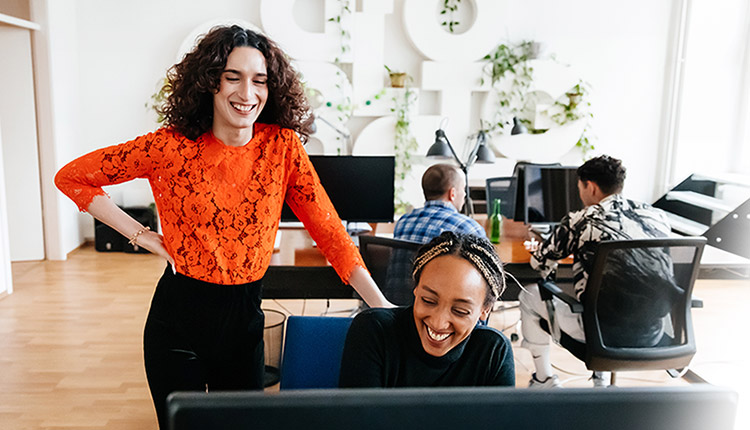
[44,0,744,254]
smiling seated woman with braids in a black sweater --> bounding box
[339,232,516,388]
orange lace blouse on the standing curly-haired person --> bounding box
[55,123,365,285]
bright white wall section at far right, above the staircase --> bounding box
[672,0,750,182]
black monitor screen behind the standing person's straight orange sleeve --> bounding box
[281,155,395,222]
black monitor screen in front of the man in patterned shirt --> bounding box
[523,165,583,224]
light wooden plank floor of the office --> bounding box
[0,246,750,429]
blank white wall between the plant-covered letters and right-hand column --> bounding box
[502,0,676,202]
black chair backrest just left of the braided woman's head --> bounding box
[359,236,422,306]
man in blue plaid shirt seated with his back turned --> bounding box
[393,164,487,243]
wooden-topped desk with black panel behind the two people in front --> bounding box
[263,216,572,300]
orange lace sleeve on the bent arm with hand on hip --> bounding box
[55,133,162,212]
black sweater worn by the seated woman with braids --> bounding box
[339,306,516,388]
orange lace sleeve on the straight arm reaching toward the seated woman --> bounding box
[285,130,365,283]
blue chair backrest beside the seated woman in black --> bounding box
[280,315,352,390]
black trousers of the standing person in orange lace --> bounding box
[143,265,265,429]
